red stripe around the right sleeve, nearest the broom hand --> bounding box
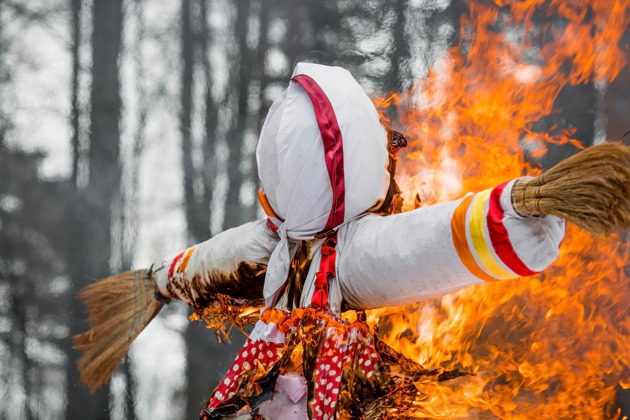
[486,182,538,276]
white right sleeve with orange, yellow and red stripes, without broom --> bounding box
[338,177,564,309]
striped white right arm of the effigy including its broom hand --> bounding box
[338,143,630,308]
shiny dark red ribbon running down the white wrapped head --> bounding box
[291,74,346,232]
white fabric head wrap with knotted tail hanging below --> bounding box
[256,63,389,307]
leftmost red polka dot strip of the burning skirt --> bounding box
[207,339,284,410]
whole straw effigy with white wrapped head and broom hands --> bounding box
[75,58,630,419]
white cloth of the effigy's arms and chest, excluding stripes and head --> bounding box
[164,182,564,314]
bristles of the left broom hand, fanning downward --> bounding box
[73,270,164,392]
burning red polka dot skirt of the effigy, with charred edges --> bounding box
[201,308,452,420]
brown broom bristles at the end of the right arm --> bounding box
[512,143,630,235]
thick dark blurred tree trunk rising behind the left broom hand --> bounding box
[67,0,123,419]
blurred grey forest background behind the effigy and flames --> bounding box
[0,0,630,420]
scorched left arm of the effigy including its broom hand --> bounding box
[73,220,278,391]
